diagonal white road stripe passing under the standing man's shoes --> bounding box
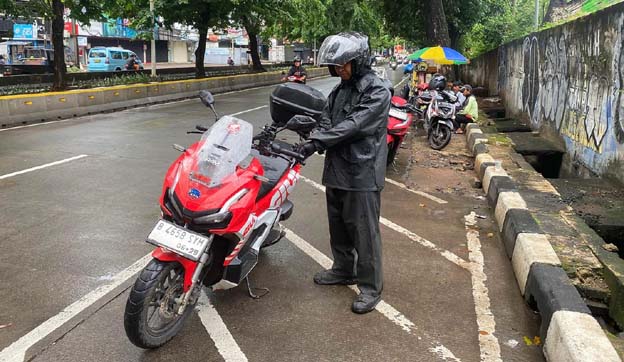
[284,228,460,361]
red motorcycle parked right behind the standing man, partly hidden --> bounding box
[386,96,414,165]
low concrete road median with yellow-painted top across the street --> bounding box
[0,68,329,128]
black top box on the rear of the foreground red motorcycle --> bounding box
[270,82,327,127]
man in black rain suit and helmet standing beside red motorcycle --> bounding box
[299,33,390,313]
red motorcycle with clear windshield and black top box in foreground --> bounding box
[124,83,325,348]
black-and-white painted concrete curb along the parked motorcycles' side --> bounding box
[466,123,621,362]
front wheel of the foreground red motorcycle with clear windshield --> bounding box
[124,259,193,348]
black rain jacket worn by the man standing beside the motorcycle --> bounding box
[309,71,390,191]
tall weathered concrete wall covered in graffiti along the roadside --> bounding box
[461,3,624,182]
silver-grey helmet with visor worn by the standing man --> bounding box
[318,32,370,76]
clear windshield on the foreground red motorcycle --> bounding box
[190,116,253,187]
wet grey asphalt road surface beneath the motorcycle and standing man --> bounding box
[0,66,543,361]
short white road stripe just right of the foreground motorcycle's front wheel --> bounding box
[195,289,247,362]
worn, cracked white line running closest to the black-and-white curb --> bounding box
[464,211,502,362]
